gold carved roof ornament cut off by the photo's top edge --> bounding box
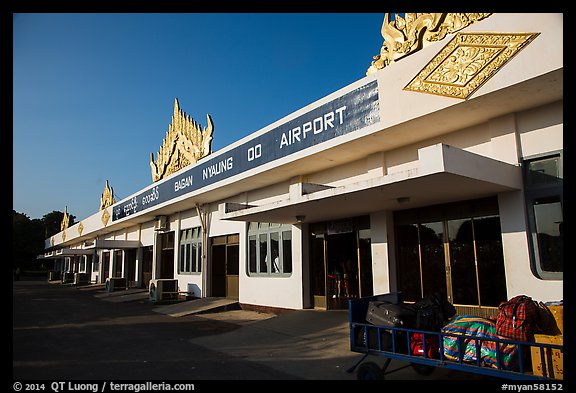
[366,12,491,75]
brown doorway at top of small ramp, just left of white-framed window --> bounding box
[210,234,240,299]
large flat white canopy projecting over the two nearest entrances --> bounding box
[219,144,522,224]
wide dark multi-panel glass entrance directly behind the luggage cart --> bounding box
[394,198,507,317]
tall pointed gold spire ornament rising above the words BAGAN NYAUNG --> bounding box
[150,98,214,181]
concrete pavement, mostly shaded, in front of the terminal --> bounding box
[13,282,486,380]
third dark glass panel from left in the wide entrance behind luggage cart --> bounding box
[448,219,479,305]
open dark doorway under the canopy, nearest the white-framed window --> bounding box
[310,216,373,310]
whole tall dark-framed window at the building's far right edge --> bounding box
[524,153,564,280]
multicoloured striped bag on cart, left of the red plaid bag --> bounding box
[442,315,518,370]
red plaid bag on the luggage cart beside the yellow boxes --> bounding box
[496,295,539,341]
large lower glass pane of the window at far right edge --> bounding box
[533,196,563,272]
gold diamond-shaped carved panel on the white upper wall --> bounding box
[404,33,540,99]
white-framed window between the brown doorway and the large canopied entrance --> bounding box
[248,222,292,276]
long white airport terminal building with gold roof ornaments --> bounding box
[42,13,563,315]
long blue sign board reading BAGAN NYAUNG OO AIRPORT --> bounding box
[112,80,380,221]
